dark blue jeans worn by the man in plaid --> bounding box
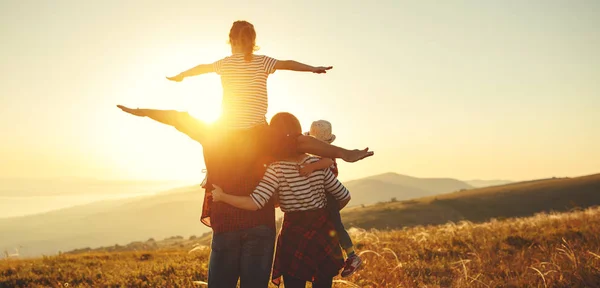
[208,226,275,288]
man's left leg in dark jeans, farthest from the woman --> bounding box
[208,231,241,288]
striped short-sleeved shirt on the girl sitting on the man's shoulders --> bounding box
[213,53,277,129]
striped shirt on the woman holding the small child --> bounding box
[250,156,350,212]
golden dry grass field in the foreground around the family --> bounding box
[0,208,600,287]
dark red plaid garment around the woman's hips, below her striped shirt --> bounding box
[272,208,344,285]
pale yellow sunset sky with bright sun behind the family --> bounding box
[0,0,600,181]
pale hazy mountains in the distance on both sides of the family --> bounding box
[0,173,472,256]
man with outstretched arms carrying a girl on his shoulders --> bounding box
[117,105,373,288]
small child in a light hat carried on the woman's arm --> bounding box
[300,120,362,277]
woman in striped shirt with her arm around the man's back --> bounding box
[212,113,350,288]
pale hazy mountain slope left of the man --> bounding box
[0,186,209,256]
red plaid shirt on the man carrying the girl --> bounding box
[200,125,297,233]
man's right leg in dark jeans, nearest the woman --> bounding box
[240,226,276,288]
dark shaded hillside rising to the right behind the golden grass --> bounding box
[342,174,600,229]
